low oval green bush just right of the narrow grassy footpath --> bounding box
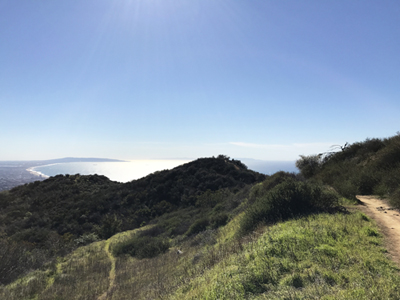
[112,235,170,259]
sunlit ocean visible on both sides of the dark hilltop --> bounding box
[29,159,297,182]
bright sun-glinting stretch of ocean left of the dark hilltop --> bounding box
[30,159,190,182]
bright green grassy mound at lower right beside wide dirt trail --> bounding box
[171,213,400,299]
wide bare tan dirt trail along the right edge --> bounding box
[357,196,400,266]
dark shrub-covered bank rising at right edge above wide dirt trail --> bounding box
[296,133,400,208]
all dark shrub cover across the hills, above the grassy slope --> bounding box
[0,134,400,284]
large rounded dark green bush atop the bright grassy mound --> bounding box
[240,179,339,234]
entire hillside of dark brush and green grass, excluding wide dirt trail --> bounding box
[0,135,400,299]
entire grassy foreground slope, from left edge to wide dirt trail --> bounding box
[0,213,400,300]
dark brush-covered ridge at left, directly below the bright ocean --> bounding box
[0,155,266,284]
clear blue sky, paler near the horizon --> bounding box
[0,0,400,160]
